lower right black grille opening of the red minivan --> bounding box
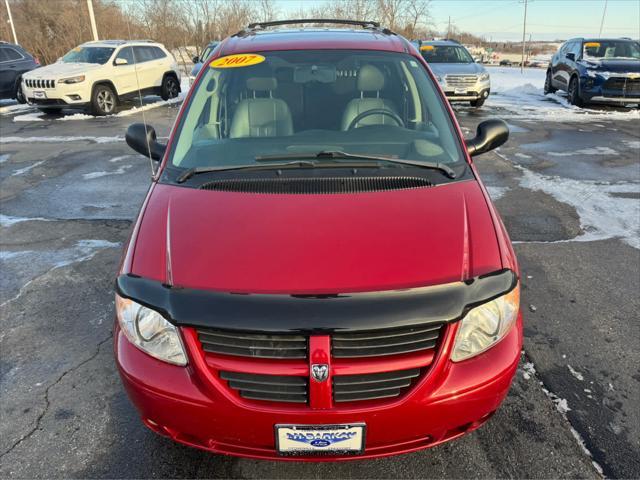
[333,368,420,403]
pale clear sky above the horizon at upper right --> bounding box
[276,0,640,41]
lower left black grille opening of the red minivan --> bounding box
[220,371,308,403]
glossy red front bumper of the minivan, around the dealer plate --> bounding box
[114,316,522,461]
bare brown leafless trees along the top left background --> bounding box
[0,0,448,64]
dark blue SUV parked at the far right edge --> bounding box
[544,38,640,106]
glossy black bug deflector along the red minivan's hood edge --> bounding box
[116,270,517,333]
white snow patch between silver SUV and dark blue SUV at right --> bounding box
[486,67,640,122]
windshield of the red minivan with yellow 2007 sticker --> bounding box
[169,50,465,179]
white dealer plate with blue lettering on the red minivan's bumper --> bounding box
[276,423,365,455]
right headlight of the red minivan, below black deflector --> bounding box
[451,285,520,362]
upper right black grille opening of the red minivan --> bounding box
[331,323,443,358]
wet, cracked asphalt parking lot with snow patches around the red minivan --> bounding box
[0,69,640,478]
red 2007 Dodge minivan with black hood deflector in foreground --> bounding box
[114,20,522,461]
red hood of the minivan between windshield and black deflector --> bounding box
[131,180,502,294]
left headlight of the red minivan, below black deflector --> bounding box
[116,295,187,365]
